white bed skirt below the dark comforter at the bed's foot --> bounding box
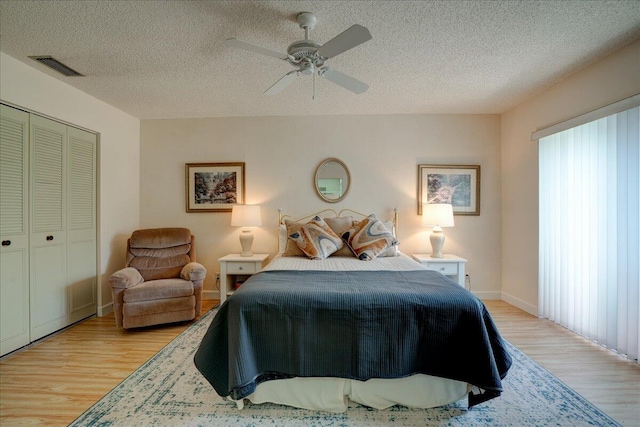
[235,374,470,412]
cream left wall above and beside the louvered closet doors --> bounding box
[0,52,140,314]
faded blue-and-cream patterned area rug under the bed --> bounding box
[71,309,619,427]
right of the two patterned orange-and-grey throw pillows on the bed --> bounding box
[342,215,398,261]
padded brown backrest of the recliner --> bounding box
[126,228,195,281]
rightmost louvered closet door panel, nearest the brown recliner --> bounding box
[67,127,97,322]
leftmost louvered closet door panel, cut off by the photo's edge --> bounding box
[0,105,29,355]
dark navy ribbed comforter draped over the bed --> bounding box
[195,270,511,407]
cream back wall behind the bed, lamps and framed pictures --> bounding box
[140,115,501,298]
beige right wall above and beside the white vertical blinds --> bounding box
[501,41,640,314]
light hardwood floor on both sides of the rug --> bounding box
[0,301,640,427]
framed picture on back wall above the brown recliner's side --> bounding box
[185,163,244,212]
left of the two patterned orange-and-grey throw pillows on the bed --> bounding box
[289,216,344,259]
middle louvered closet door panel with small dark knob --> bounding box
[30,115,69,340]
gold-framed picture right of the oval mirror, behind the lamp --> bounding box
[418,165,480,215]
